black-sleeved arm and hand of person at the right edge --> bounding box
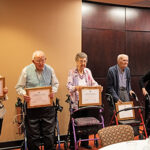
[139,71,150,96]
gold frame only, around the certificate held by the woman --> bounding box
[78,86,102,107]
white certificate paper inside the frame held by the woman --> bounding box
[82,89,99,104]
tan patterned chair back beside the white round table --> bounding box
[98,125,134,147]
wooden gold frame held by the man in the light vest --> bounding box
[25,86,53,108]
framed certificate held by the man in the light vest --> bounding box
[26,86,53,108]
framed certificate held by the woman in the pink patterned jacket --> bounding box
[79,86,102,107]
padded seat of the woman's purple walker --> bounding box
[75,117,100,126]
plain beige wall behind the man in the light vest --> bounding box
[0,0,81,142]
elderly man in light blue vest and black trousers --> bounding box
[16,51,59,150]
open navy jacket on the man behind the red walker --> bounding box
[106,65,131,103]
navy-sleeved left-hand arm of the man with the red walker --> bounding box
[107,69,121,103]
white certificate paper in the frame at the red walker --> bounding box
[118,104,134,119]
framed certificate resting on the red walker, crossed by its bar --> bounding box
[115,101,135,120]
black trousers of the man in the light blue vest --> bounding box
[25,107,55,150]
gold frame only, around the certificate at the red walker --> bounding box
[115,101,135,120]
